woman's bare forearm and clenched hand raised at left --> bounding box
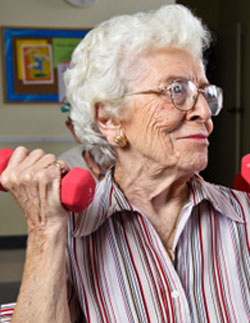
[1,147,70,323]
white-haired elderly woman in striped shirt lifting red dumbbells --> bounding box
[2,5,250,323]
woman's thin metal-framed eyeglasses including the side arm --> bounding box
[125,78,223,116]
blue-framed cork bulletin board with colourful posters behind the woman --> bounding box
[2,27,89,103]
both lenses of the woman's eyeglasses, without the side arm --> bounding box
[168,79,222,115]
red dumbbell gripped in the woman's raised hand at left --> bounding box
[0,148,96,212]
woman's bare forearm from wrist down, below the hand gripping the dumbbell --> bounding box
[12,230,70,323]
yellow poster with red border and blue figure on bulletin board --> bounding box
[21,44,54,84]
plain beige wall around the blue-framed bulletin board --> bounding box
[0,0,175,236]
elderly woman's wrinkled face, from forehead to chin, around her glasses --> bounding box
[122,49,213,173]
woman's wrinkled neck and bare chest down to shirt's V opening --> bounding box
[114,153,190,253]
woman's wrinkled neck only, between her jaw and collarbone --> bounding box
[114,154,190,211]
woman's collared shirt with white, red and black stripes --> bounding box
[0,172,250,323]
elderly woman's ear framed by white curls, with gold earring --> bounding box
[95,102,122,146]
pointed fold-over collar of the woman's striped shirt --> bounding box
[73,168,245,236]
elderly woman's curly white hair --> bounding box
[65,5,211,165]
